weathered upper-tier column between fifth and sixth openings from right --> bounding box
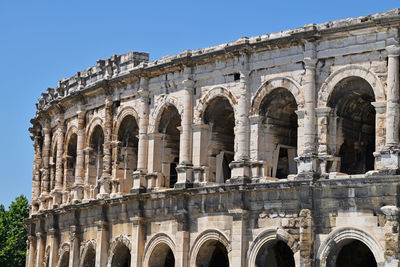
[97,98,113,199]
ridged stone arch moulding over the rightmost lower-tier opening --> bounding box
[316,227,385,267]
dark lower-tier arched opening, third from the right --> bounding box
[196,240,229,267]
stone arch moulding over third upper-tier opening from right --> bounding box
[193,86,238,124]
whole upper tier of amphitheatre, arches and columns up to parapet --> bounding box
[30,9,400,214]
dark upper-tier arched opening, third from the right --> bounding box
[203,97,235,183]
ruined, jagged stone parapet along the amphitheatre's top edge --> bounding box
[37,8,400,112]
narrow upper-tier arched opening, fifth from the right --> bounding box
[113,115,139,193]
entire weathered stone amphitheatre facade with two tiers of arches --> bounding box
[25,9,400,267]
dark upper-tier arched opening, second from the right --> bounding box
[259,88,297,178]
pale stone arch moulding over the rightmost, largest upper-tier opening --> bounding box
[317,65,386,107]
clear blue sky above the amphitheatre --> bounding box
[0,0,400,206]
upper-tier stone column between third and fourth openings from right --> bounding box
[175,67,194,188]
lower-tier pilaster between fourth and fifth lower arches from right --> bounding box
[130,217,145,267]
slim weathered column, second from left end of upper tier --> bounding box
[40,127,51,209]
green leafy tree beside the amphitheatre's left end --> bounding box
[0,195,29,267]
